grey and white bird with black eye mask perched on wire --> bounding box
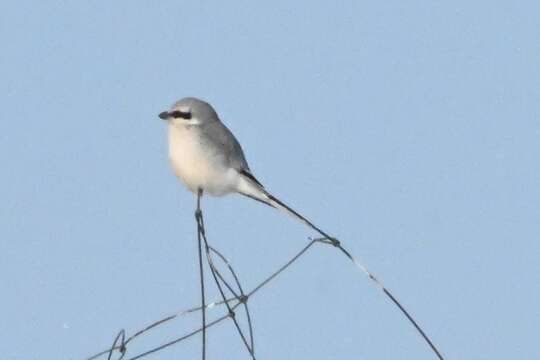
[159,97,336,241]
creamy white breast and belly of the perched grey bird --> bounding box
[169,124,238,196]
